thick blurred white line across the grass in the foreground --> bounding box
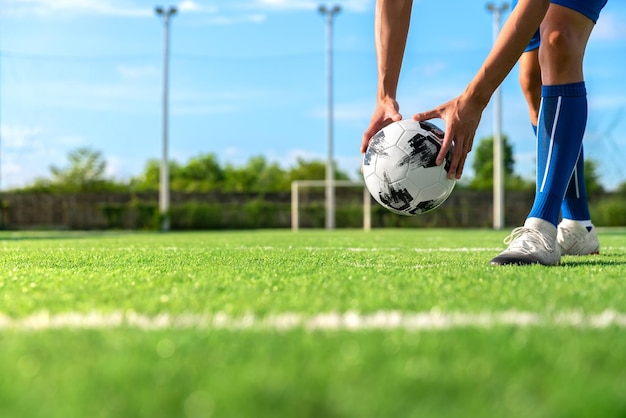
[0,310,626,332]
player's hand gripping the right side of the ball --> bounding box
[413,95,484,180]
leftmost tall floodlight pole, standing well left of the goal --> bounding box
[154,6,177,231]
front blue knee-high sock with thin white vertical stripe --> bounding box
[528,82,587,226]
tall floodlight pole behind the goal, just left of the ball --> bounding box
[318,5,341,229]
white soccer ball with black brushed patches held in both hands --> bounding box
[363,119,456,216]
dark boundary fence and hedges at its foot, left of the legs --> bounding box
[1,188,532,230]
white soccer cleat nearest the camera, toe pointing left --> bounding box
[491,218,561,266]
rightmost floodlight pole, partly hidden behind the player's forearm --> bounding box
[487,3,509,229]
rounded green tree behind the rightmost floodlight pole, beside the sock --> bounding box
[468,135,533,190]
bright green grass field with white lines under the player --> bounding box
[0,229,626,418]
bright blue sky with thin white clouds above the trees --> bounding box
[0,0,626,189]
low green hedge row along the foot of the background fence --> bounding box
[100,195,626,230]
